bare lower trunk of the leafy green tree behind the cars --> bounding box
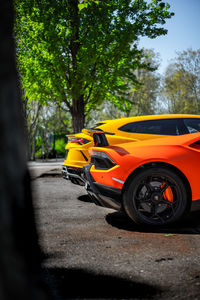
[71,96,85,133]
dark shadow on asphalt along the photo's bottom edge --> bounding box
[44,268,160,300]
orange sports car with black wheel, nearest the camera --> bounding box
[85,132,200,225]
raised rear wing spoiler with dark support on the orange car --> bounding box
[82,129,110,147]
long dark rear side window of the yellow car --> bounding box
[119,119,180,135]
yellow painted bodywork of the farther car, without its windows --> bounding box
[64,114,200,183]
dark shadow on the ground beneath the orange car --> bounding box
[105,211,200,234]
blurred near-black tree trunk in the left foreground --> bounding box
[0,0,50,300]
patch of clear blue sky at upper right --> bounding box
[139,0,200,73]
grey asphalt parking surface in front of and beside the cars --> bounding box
[29,161,200,300]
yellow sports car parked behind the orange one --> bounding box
[62,114,200,185]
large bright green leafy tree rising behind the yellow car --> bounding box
[16,0,173,132]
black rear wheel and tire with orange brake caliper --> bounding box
[123,167,188,226]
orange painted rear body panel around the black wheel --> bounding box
[90,133,200,201]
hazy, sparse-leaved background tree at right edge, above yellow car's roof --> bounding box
[164,49,200,114]
